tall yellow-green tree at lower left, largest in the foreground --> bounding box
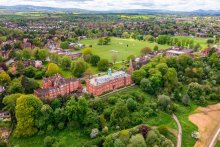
[15,95,43,137]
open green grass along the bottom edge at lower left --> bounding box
[10,129,90,147]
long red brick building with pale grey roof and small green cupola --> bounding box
[86,71,132,96]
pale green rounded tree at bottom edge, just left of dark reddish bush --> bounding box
[129,134,146,147]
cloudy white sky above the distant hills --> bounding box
[0,0,220,11]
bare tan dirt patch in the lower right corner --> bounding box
[189,103,220,147]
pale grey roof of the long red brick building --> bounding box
[90,71,129,86]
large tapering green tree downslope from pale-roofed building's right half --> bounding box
[110,101,129,128]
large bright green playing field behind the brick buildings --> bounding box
[80,37,169,62]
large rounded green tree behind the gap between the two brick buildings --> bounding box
[71,59,87,77]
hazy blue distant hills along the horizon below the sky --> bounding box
[0,5,220,15]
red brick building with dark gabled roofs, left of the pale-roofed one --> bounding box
[34,74,82,100]
